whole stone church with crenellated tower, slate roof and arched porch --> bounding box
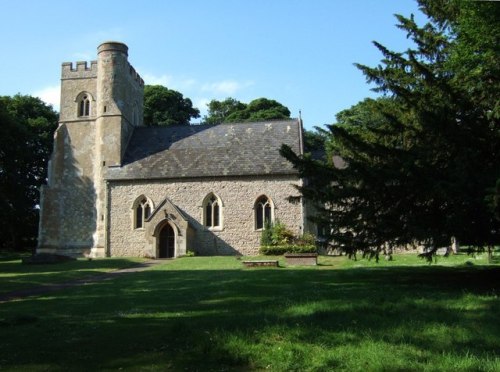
[37,42,306,258]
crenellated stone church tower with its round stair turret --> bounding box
[37,42,144,256]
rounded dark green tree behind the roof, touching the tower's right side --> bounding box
[144,85,200,126]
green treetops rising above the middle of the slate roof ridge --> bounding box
[204,98,290,124]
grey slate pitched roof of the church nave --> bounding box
[106,120,302,180]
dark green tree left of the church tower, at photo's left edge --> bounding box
[0,94,57,249]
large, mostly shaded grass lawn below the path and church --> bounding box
[0,255,500,371]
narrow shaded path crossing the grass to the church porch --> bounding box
[0,260,165,304]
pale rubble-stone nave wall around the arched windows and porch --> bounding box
[107,176,303,256]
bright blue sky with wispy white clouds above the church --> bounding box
[0,0,424,128]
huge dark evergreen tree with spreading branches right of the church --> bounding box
[282,1,500,257]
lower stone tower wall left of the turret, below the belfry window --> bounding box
[39,122,96,254]
